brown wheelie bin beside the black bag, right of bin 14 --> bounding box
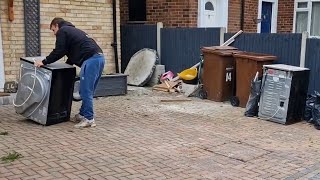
[234,52,277,107]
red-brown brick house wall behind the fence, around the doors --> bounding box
[120,0,294,32]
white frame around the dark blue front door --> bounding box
[257,0,278,33]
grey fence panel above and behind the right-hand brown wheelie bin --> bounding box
[225,33,302,66]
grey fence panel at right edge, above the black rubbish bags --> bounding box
[306,39,320,93]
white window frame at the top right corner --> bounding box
[292,0,320,38]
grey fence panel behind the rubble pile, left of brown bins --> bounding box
[161,28,220,73]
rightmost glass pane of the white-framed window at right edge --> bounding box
[310,2,320,36]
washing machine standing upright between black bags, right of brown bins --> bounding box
[259,64,310,124]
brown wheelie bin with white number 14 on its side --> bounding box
[201,46,240,102]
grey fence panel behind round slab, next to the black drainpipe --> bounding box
[120,24,157,72]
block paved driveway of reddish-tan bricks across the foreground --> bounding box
[0,88,320,180]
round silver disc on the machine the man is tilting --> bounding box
[14,71,48,117]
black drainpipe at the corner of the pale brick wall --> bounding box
[111,0,119,73]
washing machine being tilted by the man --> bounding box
[14,57,76,126]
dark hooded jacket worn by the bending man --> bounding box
[42,21,102,67]
